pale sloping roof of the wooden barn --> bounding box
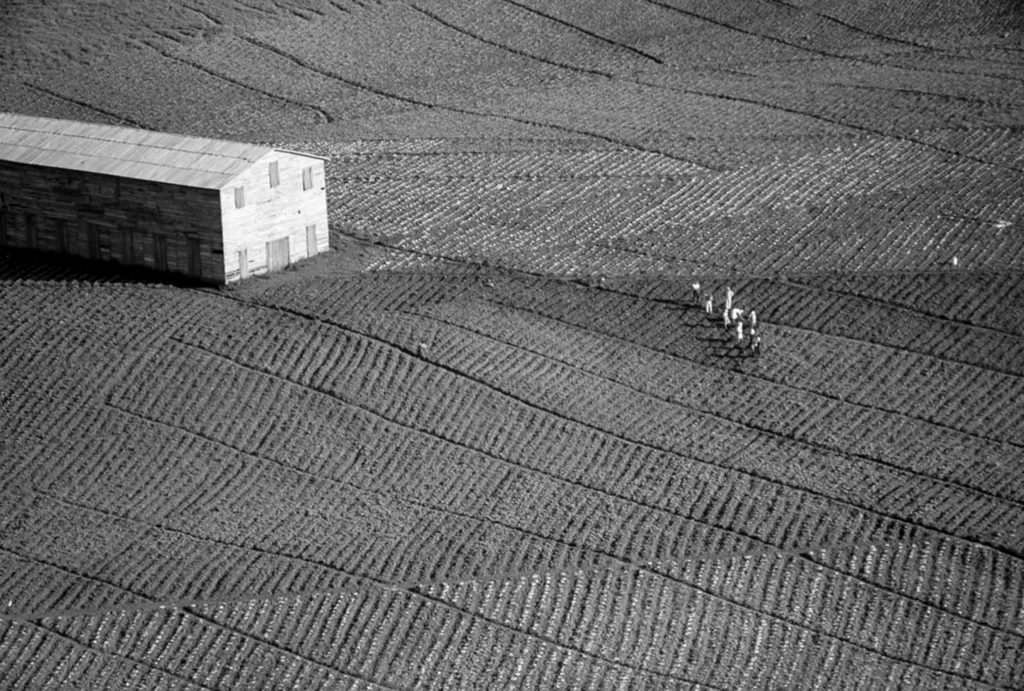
[0,113,321,189]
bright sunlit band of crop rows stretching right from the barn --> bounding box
[330,125,1024,274]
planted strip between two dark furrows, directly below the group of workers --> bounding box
[411,292,1024,502]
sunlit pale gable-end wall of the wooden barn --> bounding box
[220,152,331,282]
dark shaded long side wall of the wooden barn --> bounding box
[0,162,224,283]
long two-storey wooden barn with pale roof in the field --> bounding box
[0,113,330,284]
